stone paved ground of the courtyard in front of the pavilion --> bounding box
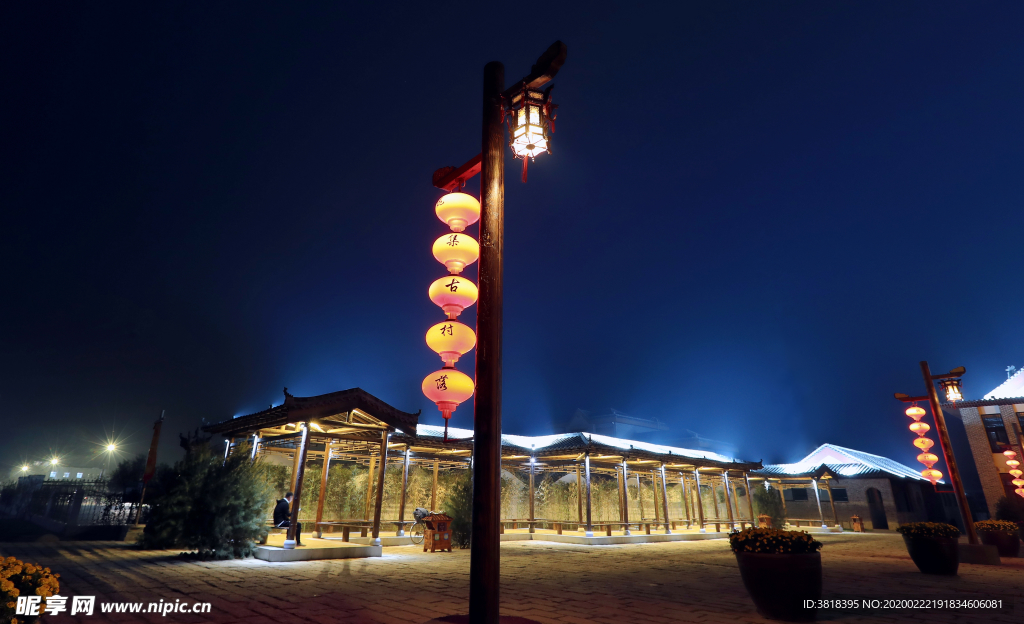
[0,534,1024,624]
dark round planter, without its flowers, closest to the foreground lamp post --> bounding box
[735,552,821,622]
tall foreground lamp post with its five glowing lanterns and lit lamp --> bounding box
[423,41,566,624]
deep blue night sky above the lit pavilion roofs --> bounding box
[0,1,1024,477]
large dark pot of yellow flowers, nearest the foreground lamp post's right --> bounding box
[729,529,821,622]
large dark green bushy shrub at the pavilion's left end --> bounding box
[139,444,272,558]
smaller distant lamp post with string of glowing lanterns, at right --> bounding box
[894,362,980,544]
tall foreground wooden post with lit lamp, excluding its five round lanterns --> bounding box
[433,41,566,624]
